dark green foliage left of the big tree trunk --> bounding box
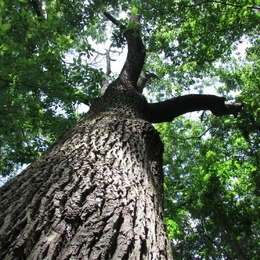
[0,1,103,175]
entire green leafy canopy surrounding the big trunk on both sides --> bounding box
[0,0,260,259]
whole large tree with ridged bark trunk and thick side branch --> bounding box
[0,0,258,259]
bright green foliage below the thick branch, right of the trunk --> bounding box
[158,35,260,259]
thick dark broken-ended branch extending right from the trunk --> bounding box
[147,95,243,123]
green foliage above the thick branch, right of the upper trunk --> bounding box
[144,0,259,99]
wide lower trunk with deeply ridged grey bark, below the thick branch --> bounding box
[0,116,173,260]
